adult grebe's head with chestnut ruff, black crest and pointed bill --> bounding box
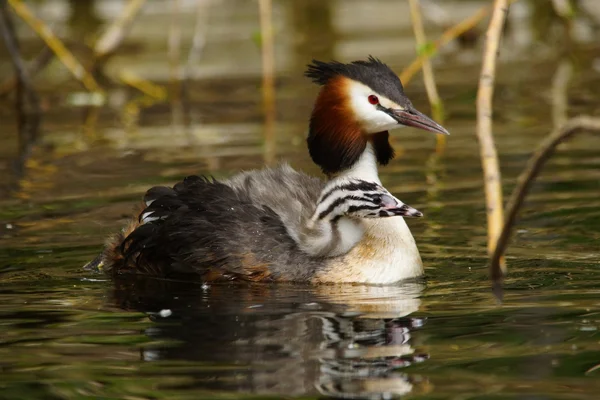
[305,56,448,175]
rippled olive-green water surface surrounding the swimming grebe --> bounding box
[0,0,600,400]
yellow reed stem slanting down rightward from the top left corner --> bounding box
[8,0,102,92]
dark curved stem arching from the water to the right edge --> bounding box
[490,116,600,284]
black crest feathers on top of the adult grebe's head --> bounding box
[304,56,408,105]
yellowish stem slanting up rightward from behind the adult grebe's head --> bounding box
[400,0,517,85]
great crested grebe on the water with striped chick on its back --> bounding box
[92,57,448,284]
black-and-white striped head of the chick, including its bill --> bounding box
[313,179,423,221]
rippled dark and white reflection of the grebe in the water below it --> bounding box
[112,278,428,399]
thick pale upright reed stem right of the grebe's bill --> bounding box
[477,0,508,272]
